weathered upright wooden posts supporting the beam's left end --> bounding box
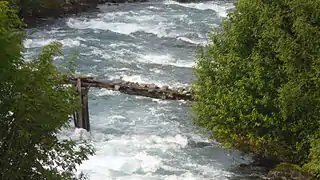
[73,78,90,131]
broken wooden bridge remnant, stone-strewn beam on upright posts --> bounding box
[70,77,193,131]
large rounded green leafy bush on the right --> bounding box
[193,0,320,164]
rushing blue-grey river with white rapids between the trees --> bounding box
[24,1,262,180]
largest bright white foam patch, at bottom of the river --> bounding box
[78,134,191,180]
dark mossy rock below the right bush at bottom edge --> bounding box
[268,163,314,180]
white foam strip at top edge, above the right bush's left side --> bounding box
[165,0,234,17]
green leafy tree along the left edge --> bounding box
[0,1,93,180]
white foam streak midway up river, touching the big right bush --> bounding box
[136,54,194,68]
